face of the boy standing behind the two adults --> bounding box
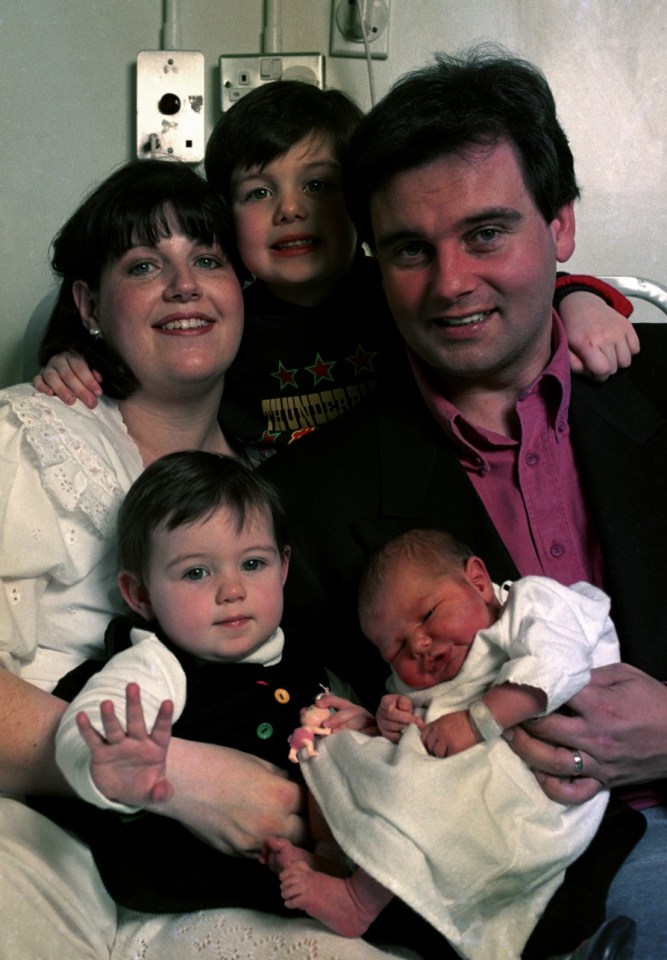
[231,136,357,306]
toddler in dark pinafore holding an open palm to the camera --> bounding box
[48,451,369,912]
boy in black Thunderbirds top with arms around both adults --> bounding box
[35,80,637,460]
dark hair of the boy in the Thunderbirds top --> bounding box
[204,80,363,200]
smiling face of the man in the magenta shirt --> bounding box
[371,142,574,394]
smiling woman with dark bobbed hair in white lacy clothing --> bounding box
[0,161,350,960]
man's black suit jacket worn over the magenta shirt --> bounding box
[261,324,667,701]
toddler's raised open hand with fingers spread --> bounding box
[76,683,174,807]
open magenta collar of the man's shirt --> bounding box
[408,310,571,473]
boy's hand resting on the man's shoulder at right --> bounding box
[558,290,639,380]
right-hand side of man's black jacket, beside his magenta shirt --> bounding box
[570,372,667,679]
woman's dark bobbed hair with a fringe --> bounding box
[39,160,244,400]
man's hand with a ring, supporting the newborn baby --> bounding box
[504,663,667,803]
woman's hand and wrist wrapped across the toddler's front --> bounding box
[151,737,307,857]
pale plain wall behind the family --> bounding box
[0,0,667,386]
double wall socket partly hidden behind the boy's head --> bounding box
[220,53,325,112]
